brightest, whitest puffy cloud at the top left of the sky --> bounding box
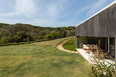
[15,0,36,17]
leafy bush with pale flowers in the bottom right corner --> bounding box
[90,58,116,77]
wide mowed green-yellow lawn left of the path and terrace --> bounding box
[0,39,90,77]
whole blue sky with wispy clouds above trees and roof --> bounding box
[0,0,115,27]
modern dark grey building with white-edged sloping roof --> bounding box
[75,1,116,63]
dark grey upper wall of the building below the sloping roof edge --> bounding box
[75,3,116,37]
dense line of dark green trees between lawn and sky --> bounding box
[0,23,75,44]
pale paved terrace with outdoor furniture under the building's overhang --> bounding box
[76,44,115,66]
